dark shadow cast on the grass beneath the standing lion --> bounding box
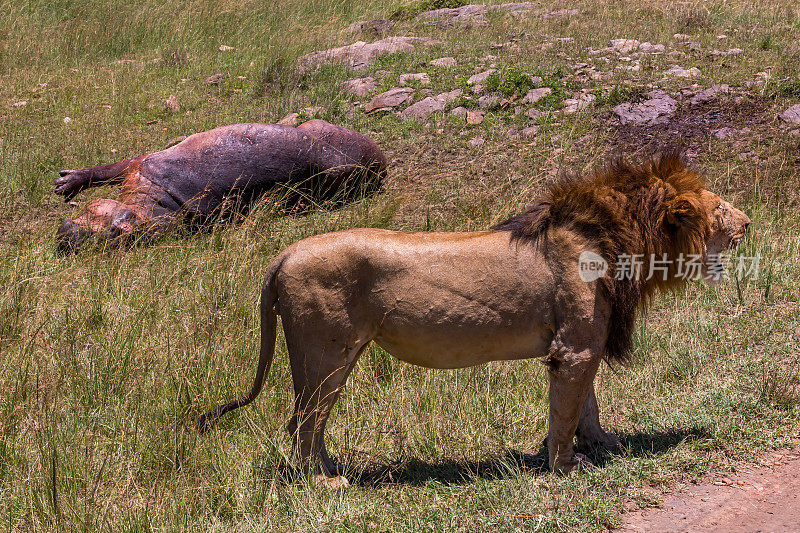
[347,428,708,486]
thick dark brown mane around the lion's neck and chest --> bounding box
[494,152,710,362]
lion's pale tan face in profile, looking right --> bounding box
[701,191,750,285]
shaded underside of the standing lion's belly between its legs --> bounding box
[375,326,553,368]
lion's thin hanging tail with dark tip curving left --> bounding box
[195,256,283,433]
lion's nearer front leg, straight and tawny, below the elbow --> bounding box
[547,350,601,474]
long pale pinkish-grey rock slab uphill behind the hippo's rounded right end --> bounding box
[297,37,439,72]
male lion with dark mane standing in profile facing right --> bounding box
[197,154,750,483]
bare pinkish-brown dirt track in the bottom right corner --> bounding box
[617,448,800,533]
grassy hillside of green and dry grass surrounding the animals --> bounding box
[0,0,800,531]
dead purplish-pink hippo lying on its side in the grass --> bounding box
[55,120,386,252]
